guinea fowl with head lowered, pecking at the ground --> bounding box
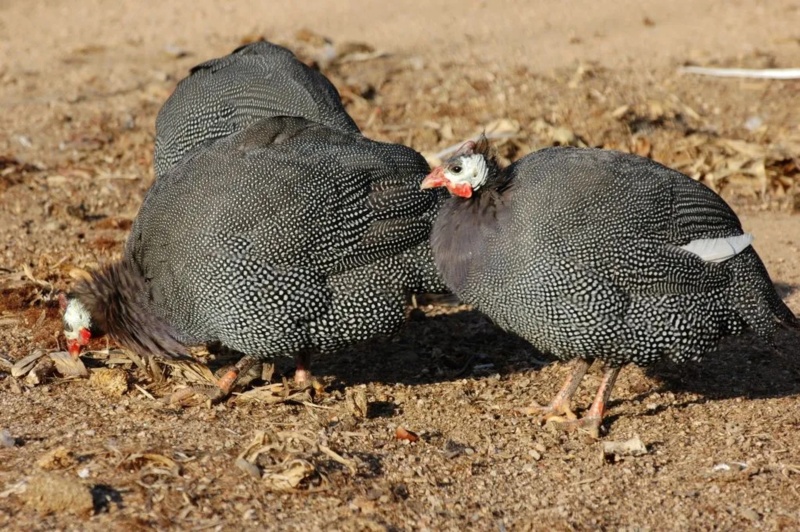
[64,117,440,400]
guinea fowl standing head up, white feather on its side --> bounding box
[421,138,798,437]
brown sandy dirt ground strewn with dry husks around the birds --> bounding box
[0,0,800,530]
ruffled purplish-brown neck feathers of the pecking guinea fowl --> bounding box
[71,260,191,359]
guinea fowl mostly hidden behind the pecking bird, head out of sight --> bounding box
[154,41,359,176]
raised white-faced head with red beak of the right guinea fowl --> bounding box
[420,135,498,198]
